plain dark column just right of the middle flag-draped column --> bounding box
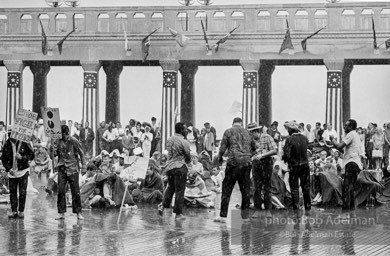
[179,63,198,125]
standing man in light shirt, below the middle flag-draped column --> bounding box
[159,122,191,220]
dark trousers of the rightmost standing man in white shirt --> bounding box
[343,162,360,211]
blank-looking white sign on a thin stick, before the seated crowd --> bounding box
[121,156,149,179]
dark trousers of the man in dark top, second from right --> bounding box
[288,164,311,210]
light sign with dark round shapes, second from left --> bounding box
[41,107,61,139]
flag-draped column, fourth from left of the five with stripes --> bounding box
[240,60,260,126]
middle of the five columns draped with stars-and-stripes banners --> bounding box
[160,60,180,150]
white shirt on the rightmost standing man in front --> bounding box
[343,131,362,169]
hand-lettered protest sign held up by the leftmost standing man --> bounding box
[11,109,38,142]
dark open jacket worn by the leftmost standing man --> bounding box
[1,139,34,172]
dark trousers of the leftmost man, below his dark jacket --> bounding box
[9,172,28,212]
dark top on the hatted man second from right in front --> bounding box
[283,133,309,167]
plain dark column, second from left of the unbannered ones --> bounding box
[103,61,123,122]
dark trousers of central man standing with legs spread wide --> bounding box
[219,164,252,219]
